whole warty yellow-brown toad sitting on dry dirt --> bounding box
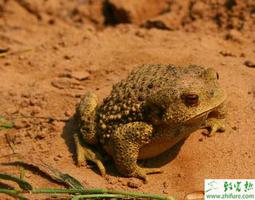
[74,64,226,181]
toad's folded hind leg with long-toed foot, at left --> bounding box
[74,92,105,175]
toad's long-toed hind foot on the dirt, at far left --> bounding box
[74,134,106,176]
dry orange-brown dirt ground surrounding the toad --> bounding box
[0,0,255,199]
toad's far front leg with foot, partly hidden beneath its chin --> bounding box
[203,103,227,136]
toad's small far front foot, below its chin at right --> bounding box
[203,118,225,137]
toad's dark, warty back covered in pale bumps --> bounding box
[97,64,205,143]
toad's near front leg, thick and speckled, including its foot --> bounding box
[113,122,161,182]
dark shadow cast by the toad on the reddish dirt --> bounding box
[61,116,185,176]
